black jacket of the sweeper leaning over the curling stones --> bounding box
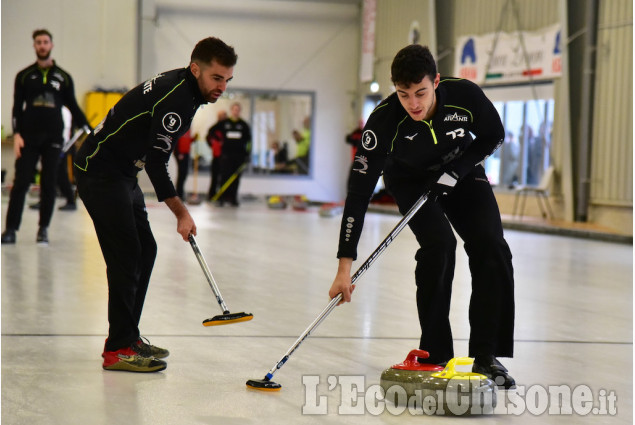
[337,77,505,259]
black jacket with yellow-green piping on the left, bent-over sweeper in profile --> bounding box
[75,67,206,201]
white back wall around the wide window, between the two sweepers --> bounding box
[141,0,359,201]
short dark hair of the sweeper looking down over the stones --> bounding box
[390,44,437,88]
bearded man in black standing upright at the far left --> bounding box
[1,29,90,244]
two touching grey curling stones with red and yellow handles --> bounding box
[380,350,497,416]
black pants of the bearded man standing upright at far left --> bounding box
[6,133,63,230]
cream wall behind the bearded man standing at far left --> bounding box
[0,0,137,132]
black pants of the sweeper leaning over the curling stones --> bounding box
[385,166,514,363]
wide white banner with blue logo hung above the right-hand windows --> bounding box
[454,24,562,85]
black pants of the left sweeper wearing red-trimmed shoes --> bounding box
[76,171,157,351]
